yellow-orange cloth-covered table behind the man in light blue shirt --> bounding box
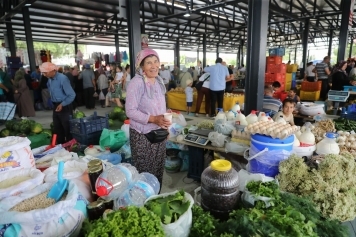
[167,92,245,114]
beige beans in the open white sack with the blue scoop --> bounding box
[10,191,67,212]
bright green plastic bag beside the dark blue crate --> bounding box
[99,128,127,152]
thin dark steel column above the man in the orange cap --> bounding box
[22,7,36,72]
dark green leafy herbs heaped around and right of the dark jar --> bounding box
[190,181,348,237]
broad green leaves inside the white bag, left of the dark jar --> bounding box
[145,190,190,225]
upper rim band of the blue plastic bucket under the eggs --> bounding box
[250,134,294,155]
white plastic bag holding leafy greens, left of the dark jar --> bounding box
[145,191,194,237]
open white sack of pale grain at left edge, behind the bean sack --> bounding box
[0,168,45,200]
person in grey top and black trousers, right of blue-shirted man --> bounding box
[79,64,96,109]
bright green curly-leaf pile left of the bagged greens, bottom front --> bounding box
[80,206,165,237]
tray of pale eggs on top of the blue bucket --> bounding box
[245,121,300,140]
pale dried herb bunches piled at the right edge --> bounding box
[276,152,356,221]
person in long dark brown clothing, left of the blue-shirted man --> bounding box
[14,70,36,118]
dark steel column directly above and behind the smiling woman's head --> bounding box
[126,0,141,75]
